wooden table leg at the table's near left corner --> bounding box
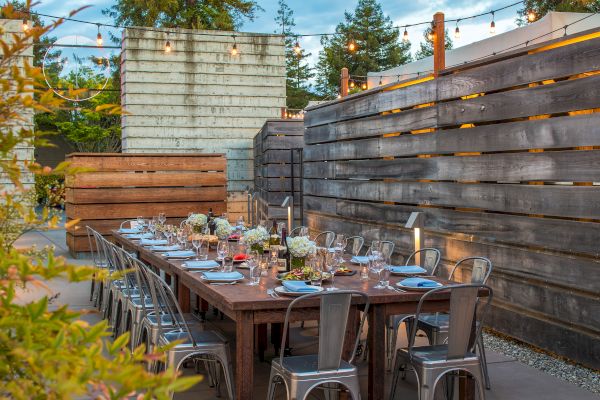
[235,311,254,400]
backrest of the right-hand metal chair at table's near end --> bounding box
[408,284,493,360]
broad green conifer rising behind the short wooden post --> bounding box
[317,0,411,96]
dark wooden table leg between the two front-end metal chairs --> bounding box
[368,304,386,399]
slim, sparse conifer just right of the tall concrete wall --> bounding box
[275,0,315,109]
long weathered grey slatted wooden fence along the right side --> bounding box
[303,32,600,368]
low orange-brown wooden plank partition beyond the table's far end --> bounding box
[66,153,227,255]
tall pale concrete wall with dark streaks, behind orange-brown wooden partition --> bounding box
[121,28,286,218]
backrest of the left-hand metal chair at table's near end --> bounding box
[279,290,369,371]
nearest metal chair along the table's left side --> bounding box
[146,262,234,399]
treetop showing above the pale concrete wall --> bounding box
[102,0,262,31]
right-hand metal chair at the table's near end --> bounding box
[390,284,492,400]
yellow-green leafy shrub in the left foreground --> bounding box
[0,2,201,400]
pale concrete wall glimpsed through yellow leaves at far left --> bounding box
[0,19,34,190]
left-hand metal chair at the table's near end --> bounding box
[267,290,369,400]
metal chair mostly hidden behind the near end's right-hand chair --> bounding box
[417,257,493,390]
